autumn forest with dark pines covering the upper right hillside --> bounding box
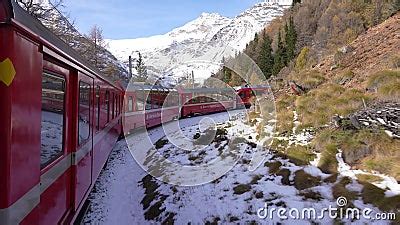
[209,0,400,86]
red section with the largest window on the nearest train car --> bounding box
[38,59,73,224]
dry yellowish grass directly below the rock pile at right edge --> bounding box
[312,129,400,180]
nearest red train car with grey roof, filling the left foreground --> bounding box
[0,0,124,225]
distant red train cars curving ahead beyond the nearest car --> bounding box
[123,84,268,133]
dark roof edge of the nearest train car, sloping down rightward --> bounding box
[0,0,122,90]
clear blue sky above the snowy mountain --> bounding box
[63,0,262,39]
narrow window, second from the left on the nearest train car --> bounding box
[78,81,91,145]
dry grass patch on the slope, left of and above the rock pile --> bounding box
[296,84,370,127]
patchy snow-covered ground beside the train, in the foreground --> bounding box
[84,111,398,224]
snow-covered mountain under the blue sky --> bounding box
[108,0,292,84]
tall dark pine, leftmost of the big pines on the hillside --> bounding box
[258,31,274,79]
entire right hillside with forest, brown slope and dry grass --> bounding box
[208,0,400,216]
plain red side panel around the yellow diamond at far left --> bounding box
[0,24,42,220]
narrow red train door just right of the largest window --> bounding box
[74,73,95,209]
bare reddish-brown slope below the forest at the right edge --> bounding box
[316,13,400,87]
